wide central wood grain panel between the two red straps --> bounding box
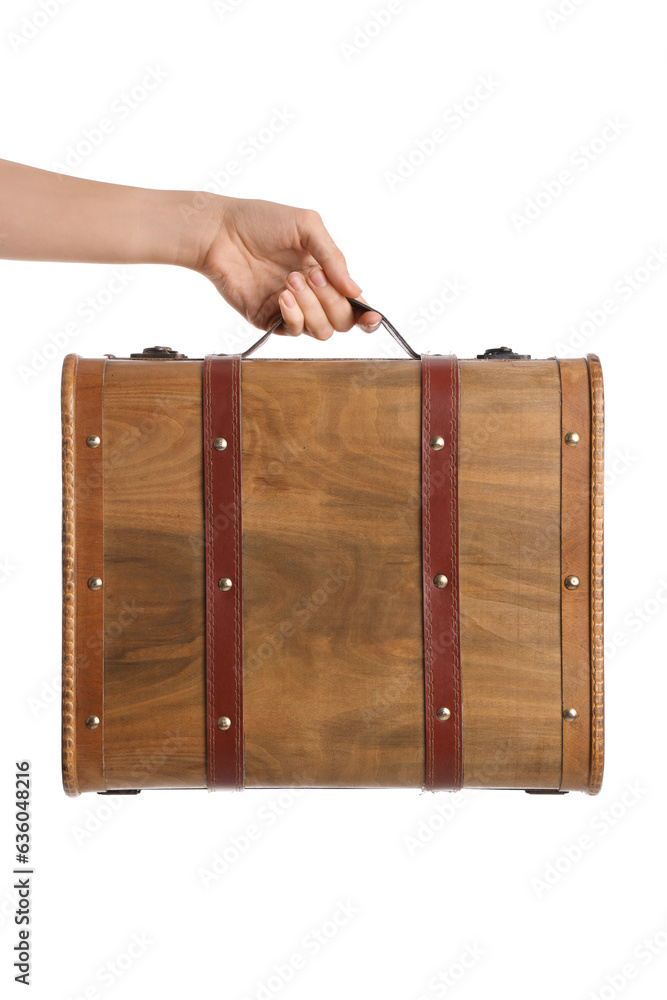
[242,360,424,787]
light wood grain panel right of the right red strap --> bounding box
[459,361,561,788]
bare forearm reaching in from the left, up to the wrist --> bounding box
[0,160,215,267]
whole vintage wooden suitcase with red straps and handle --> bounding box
[62,302,604,795]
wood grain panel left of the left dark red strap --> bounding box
[104,360,206,789]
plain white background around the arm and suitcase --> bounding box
[0,0,667,1000]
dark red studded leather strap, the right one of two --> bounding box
[422,354,463,791]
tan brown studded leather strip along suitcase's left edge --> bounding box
[70,358,106,792]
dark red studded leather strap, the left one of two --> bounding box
[203,355,244,790]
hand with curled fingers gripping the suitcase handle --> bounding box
[196,197,380,340]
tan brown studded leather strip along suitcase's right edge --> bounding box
[558,358,591,791]
